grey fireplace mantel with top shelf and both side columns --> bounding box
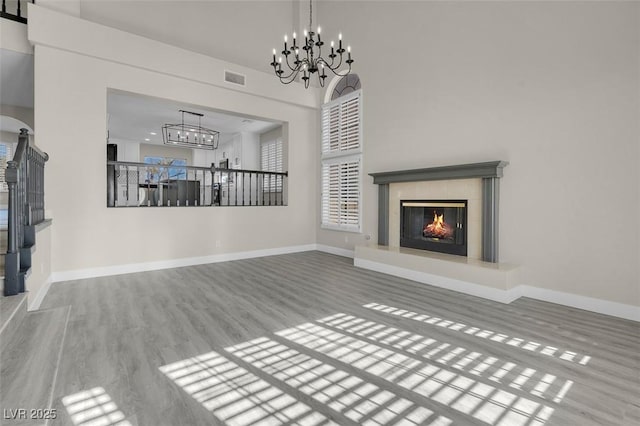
[369,161,509,263]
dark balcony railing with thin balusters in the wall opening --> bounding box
[107,161,287,207]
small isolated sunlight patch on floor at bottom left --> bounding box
[62,387,131,426]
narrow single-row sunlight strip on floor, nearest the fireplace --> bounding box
[363,303,591,365]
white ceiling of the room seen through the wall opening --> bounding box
[107,91,282,144]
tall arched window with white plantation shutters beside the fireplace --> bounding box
[321,74,363,232]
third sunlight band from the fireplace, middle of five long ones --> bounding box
[276,323,554,426]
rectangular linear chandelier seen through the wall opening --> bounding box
[162,109,220,149]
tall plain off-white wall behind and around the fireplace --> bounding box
[317,1,640,305]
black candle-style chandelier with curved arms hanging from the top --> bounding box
[271,0,353,88]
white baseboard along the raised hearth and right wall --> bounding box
[354,255,640,322]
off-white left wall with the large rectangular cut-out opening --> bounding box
[29,5,318,276]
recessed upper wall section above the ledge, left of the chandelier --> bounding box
[80,0,296,72]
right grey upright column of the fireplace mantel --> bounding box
[482,177,500,263]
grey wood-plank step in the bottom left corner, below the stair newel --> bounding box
[0,307,71,426]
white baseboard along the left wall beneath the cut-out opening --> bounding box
[51,244,316,283]
